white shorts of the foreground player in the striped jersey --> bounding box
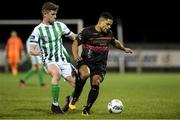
[45,62,72,79]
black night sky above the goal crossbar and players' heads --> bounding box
[0,0,180,44]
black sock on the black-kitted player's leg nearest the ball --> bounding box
[86,85,99,111]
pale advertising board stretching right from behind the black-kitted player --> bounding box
[107,49,180,72]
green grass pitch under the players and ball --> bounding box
[0,73,180,119]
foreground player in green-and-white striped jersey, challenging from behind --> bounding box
[29,2,76,114]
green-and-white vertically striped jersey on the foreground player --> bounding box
[30,21,72,63]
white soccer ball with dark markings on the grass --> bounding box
[108,99,123,113]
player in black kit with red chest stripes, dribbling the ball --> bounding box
[65,12,132,116]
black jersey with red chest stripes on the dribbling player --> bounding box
[77,26,114,65]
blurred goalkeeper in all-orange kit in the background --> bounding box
[6,30,24,75]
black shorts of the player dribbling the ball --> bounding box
[77,60,106,81]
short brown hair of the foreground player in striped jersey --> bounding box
[42,2,59,11]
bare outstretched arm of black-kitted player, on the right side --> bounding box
[112,39,133,53]
